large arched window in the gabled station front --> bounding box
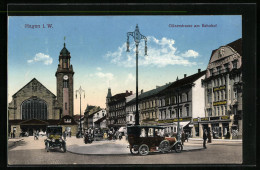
[21,98,47,120]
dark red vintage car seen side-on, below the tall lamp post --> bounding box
[127,125,183,155]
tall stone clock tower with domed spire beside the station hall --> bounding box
[55,43,74,116]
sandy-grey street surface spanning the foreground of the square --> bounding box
[8,137,242,165]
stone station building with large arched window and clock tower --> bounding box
[8,43,78,136]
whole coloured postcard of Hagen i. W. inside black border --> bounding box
[7,4,254,166]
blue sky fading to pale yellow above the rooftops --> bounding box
[8,15,242,114]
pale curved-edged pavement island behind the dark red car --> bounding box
[66,137,203,155]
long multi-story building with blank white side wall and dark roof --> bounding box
[158,69,206,136]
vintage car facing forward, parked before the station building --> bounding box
[44,126,67,152]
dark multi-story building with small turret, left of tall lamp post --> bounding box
[107,91,132,130]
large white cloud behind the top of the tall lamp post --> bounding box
[104,36,199,67]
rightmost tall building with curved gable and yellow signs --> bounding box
[201,38,243,138]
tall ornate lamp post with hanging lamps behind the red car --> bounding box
[126,24,147,125]
